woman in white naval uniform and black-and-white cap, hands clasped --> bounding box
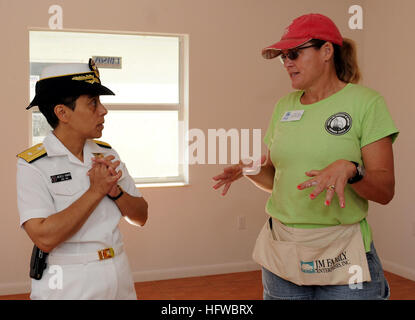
[17,60,147,299]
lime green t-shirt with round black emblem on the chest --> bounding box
[264,83,398,252]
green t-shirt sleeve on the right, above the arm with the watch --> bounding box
[360,96,399,148]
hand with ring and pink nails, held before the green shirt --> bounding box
[297,160,356,208]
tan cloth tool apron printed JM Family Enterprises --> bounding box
[252,218,371,285]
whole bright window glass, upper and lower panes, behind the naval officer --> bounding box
[29,31,187,183]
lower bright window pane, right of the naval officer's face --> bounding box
[100,110,179,178]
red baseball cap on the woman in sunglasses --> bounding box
[262,13,343,59]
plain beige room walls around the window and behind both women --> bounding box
[0,0,415,294]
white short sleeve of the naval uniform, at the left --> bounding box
[16,159,55,227]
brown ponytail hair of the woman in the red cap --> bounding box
[310,38,361,83]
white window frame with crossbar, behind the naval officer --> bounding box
[27,28,189,187]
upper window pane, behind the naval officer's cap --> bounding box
[29,31,179,103]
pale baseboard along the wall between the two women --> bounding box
[133,261,260,282]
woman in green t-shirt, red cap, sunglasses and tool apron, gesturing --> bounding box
[214,14,398,299]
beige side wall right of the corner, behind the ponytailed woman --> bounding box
[363,0,415,280]
